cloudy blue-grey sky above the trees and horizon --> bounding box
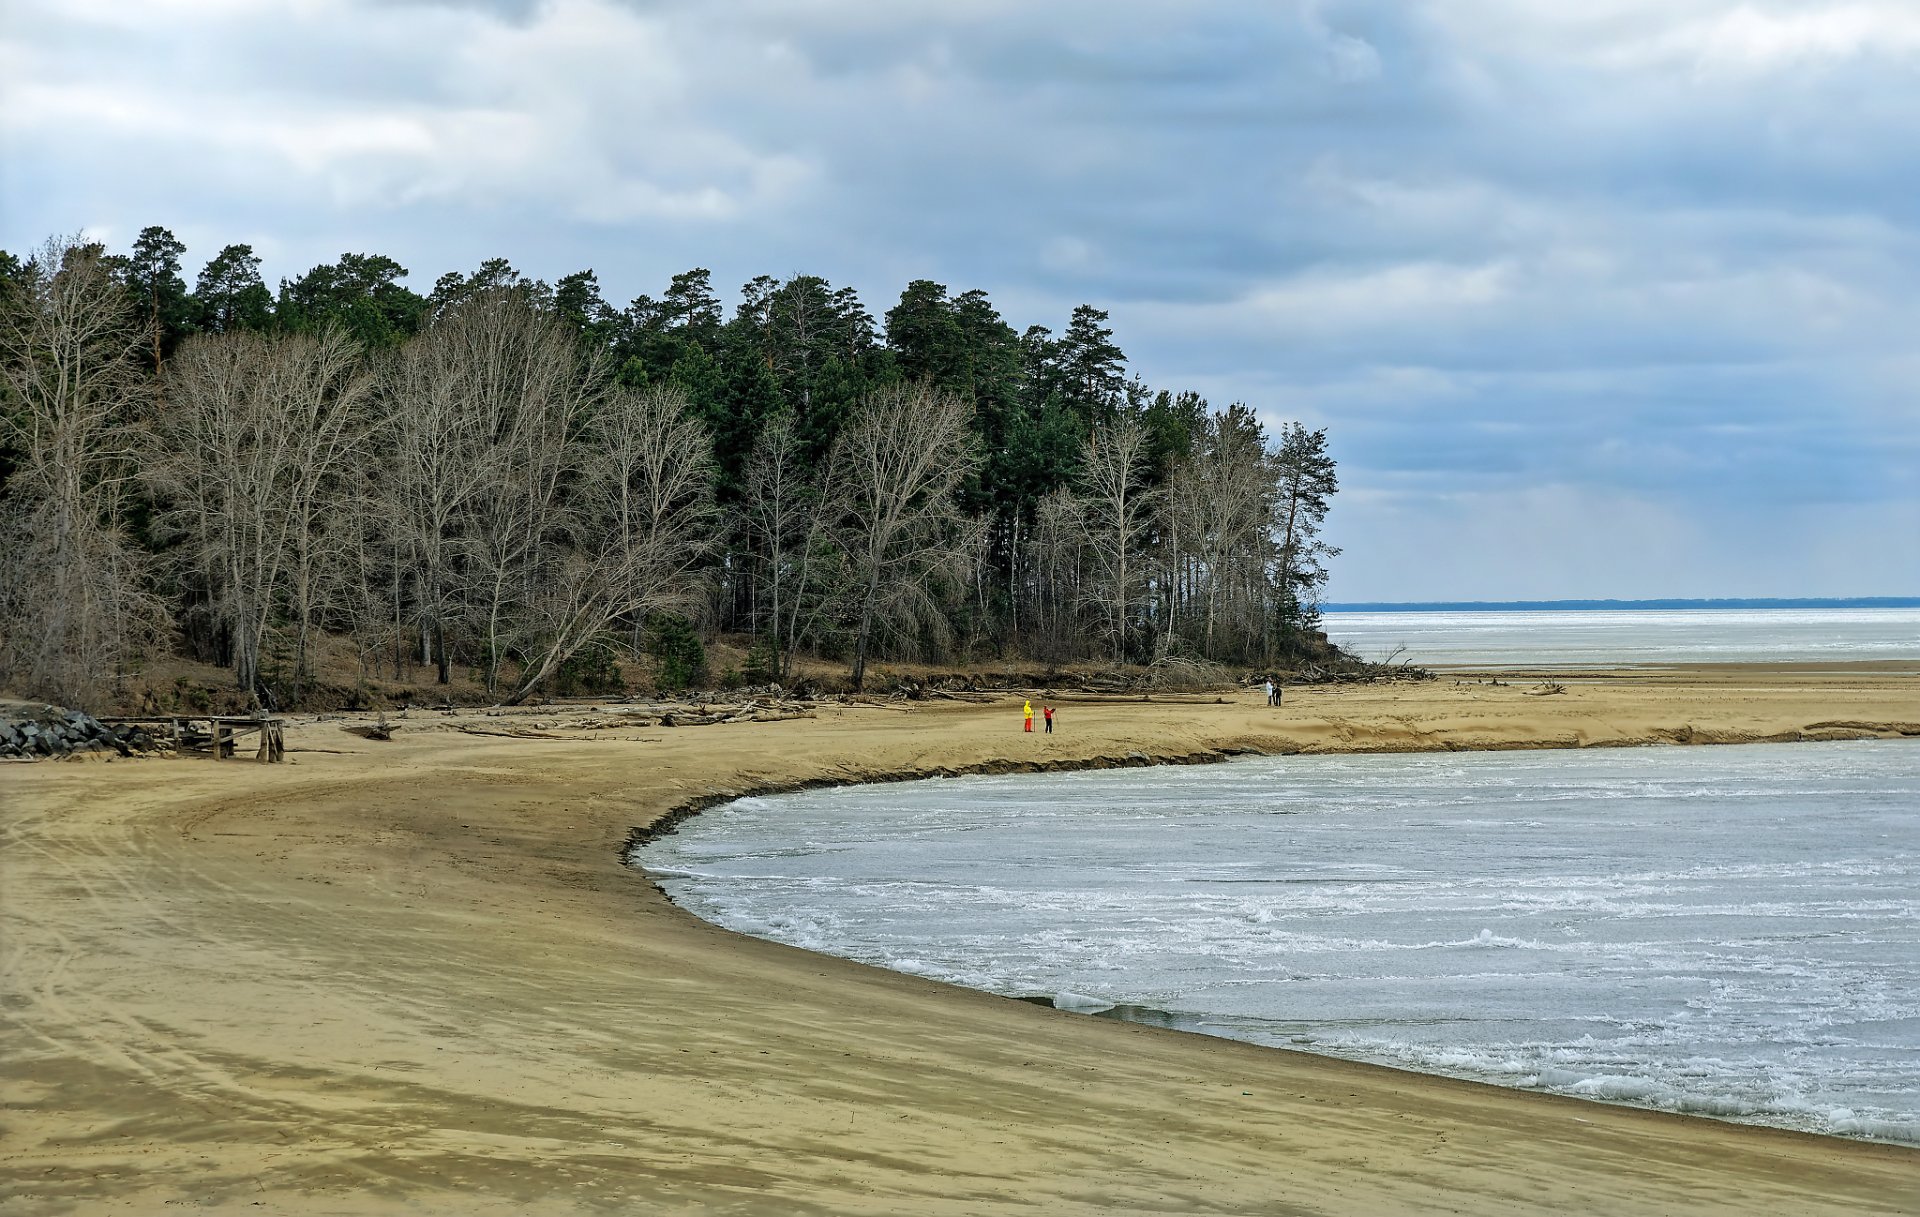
[0,0,1920,601]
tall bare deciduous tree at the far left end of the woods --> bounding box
[0,238,161,703]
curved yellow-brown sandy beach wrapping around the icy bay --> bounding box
[0,664,1920,1215]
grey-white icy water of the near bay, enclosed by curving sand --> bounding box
[636,741,1920,1142]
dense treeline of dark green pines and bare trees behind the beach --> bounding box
[0,228,1336,704]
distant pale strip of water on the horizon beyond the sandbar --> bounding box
[1323,609,1920,668]
